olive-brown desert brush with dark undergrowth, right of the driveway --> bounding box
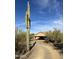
[47,28,63,53]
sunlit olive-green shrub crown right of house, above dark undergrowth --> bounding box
[47,28,63,43]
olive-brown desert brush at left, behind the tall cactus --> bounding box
[15,29,34,55]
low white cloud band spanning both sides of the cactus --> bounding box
[16,18,63,33]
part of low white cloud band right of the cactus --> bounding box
[31,18,63,32]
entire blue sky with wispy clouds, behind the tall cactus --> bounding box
[15,0,63,33]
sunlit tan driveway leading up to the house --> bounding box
[26,40,62,59]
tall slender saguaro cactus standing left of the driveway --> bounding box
[25,0,30,51]
